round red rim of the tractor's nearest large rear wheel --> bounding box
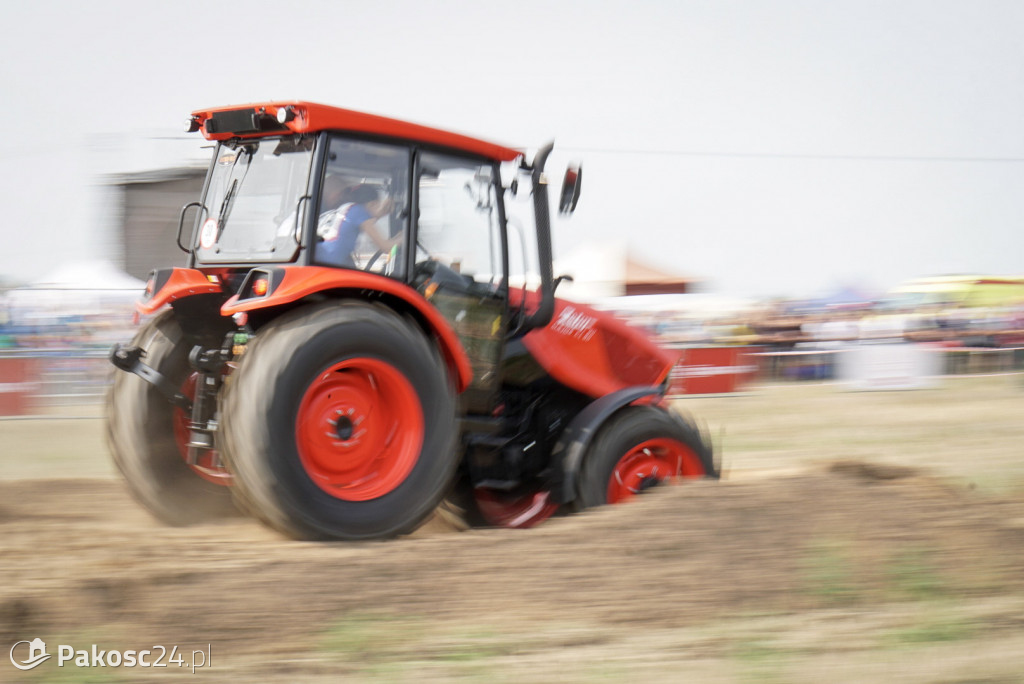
[295,357,424,501]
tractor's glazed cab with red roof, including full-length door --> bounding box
[179,103,580,405]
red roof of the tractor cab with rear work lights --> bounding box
[189,100,522,162]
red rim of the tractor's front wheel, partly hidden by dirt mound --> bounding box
[608,437,705,504]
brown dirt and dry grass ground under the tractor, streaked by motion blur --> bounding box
[0,376,1024,684]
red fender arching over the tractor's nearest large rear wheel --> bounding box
[220,266,473,392]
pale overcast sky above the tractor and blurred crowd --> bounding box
[0,0,1024,296]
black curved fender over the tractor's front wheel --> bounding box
[550,387,665,504]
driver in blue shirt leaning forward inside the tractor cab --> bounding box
[316,178,400,268]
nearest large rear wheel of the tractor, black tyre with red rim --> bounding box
[221,301,457,540]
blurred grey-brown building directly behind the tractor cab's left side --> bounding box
[112,167,206,281]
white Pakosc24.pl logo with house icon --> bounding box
[10,637,213,674]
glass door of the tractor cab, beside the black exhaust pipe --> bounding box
[413,151,508,413]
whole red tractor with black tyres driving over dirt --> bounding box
[108,101,718,540]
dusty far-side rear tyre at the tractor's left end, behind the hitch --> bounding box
[106,310,238,525]
